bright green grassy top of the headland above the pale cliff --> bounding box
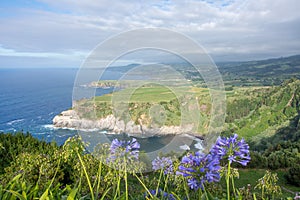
[75,84,210,126]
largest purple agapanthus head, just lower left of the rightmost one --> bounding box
[176,151,221,190]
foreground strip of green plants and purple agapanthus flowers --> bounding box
[0,133,300,199]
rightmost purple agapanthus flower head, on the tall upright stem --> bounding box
[211,134,251,166]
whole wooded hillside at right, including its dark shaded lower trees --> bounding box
[223,79,300,186]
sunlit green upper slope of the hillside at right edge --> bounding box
[226,79,300,140]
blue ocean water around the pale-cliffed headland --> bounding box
[0,68,199,152]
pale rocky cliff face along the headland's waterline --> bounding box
[53,110,193,136]
